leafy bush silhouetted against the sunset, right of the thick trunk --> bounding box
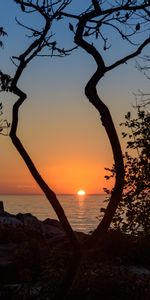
[106,105,150,235]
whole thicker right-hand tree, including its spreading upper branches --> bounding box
[63,0,150,242]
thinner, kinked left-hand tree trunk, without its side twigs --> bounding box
[8,0,80,251]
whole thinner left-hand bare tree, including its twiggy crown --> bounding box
[0,0,79,249]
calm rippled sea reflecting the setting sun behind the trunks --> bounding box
[0,195,106,233]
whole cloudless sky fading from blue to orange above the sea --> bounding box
[0,0,148,194]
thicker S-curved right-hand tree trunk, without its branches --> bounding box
[75,18,124,243]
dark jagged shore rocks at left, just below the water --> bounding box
[0,211,65,242]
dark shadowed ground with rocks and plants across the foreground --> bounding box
[0,213,150,300]
